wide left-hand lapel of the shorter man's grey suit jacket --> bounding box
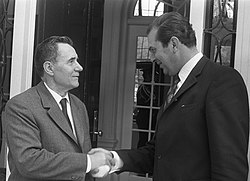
[37,82,78,144]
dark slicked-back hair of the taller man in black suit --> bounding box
[147,12,196,48]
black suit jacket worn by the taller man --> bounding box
[118,57,249,181]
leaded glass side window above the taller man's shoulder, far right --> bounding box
[204,0,238,67]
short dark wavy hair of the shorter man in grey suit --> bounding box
[34,36,73,77]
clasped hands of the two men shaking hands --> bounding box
[88,148,123,178]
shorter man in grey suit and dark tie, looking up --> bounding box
[3,36,111,181]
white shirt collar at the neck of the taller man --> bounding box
[178,52,203,84]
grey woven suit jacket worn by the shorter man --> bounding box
[3,82,91,181]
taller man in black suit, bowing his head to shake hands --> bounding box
[92,12,249,181]
